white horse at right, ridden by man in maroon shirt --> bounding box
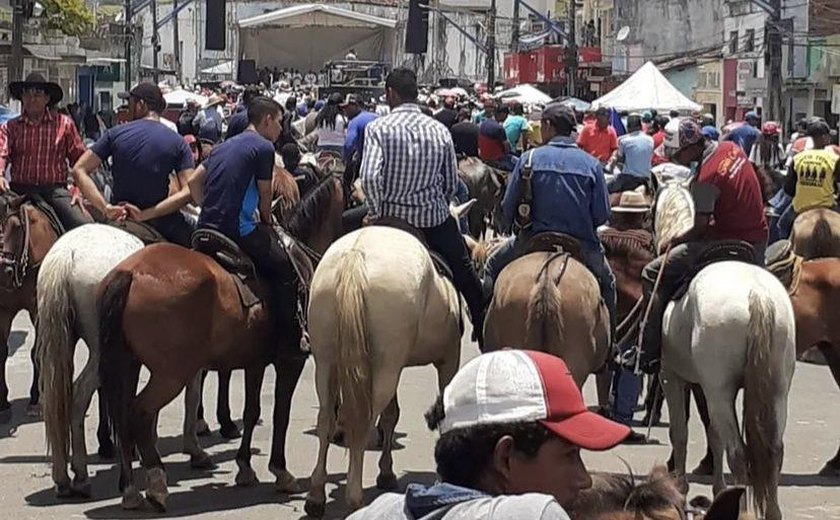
[656,181,796,520]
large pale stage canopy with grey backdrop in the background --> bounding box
[239,4,396,74]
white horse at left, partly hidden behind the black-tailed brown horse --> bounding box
[36,224,143,497]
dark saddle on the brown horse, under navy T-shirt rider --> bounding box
[192,228,262,309]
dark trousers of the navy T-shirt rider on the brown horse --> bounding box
[235,224,301,352]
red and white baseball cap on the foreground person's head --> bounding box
[439,350,630,451]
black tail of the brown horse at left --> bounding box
[98,271,136,452]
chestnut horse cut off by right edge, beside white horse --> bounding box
[768,243,840,477]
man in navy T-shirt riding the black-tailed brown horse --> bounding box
[189,96,305,359]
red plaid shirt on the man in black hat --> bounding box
[0,110,85,186]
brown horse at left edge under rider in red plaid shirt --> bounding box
[0,193,64,416]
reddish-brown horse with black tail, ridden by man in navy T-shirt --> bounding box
[99,177,344,510]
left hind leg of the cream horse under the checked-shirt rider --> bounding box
[304,361,338,518]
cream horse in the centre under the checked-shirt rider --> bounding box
[304,226,462,517]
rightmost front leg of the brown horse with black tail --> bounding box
[268,360,306,493]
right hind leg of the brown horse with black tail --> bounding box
[129,372,185,513]
